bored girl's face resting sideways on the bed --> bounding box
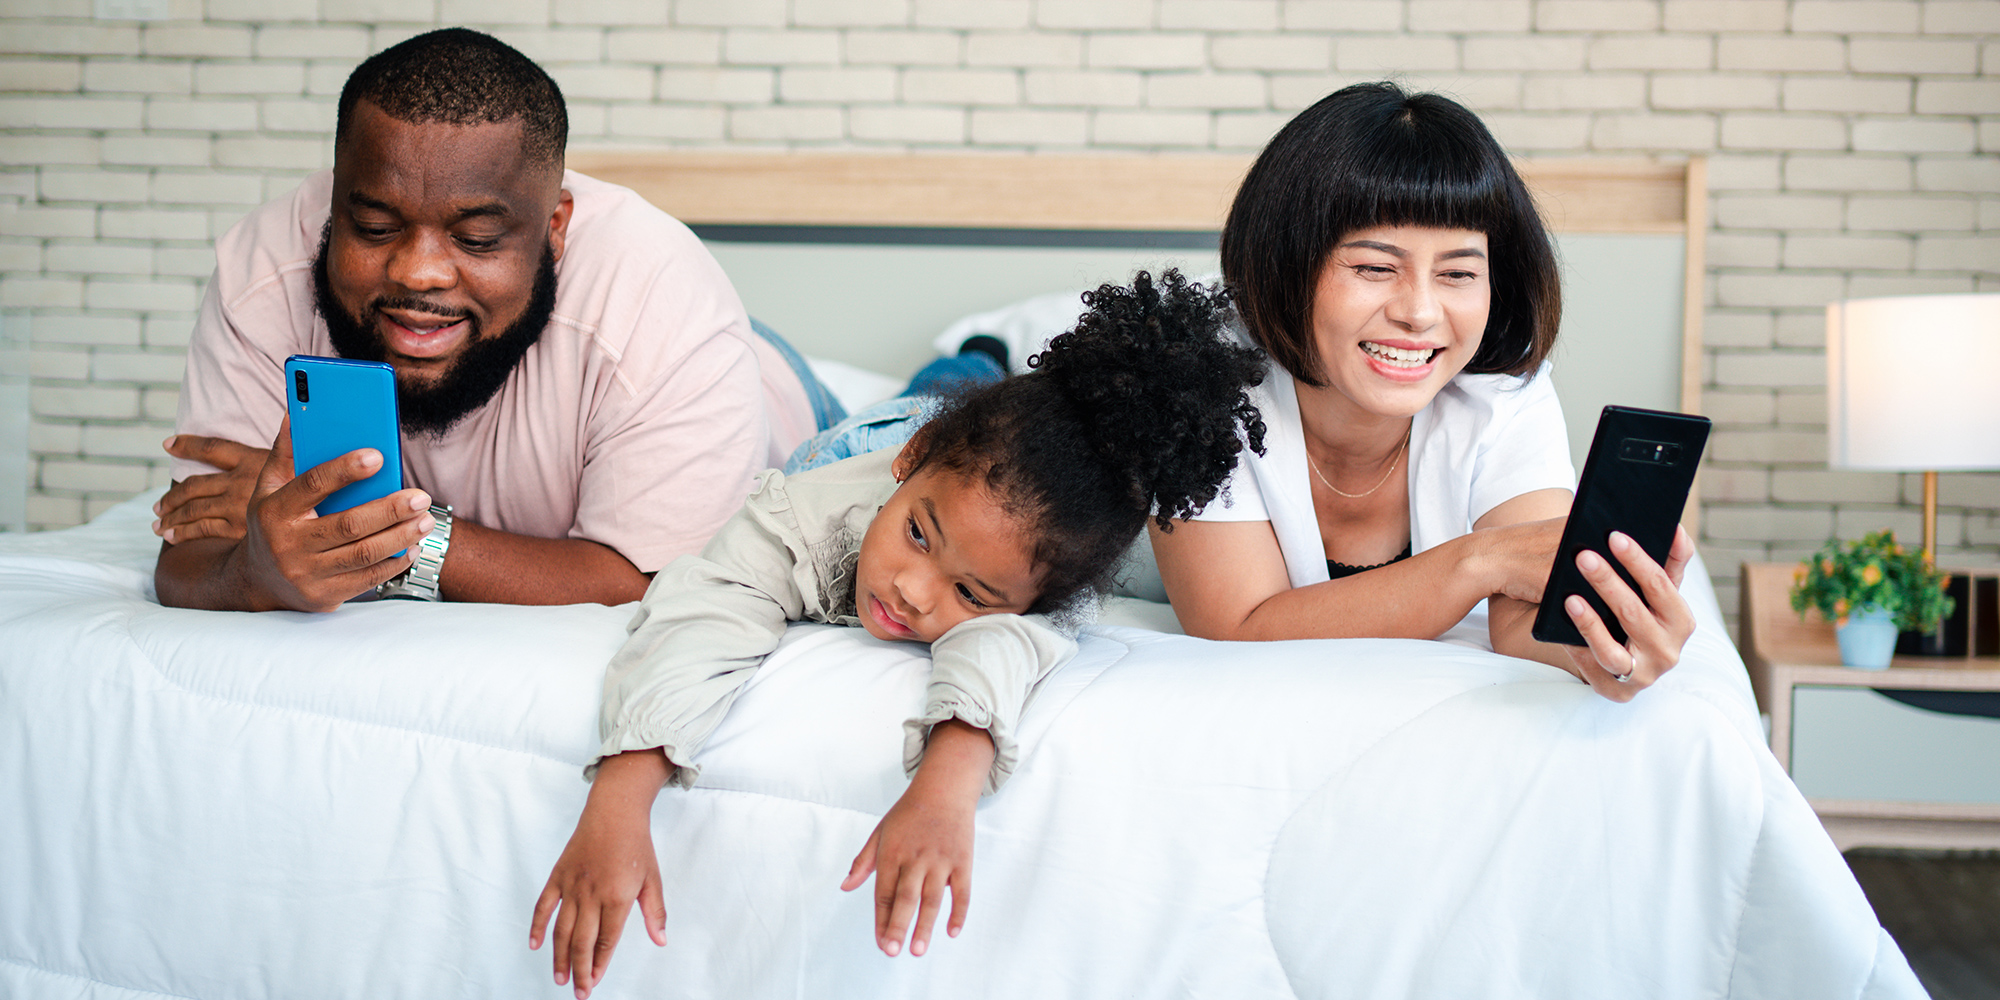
[854,462,1040,642]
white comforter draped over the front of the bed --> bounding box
[0,498,1922,998]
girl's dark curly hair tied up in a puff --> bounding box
[910,270,1264,614]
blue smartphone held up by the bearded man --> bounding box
[284,354,402,518]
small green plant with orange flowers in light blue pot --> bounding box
[1792,530,1952,670]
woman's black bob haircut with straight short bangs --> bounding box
[1222,82,1562,386]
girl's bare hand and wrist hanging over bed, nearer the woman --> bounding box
[840,718,994,960]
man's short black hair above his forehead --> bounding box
[334,28,570,168]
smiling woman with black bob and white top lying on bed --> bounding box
[1152,82,1694,702]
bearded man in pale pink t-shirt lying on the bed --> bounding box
[154,28,816,610]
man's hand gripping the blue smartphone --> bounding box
[234,418,436,612]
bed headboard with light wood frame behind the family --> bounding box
[570,150,1708,530]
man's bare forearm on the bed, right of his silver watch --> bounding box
[438,520,652,604]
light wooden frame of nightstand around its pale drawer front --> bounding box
[1740,562,2000,850]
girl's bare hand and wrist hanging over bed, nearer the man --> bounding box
[528,750,674,998]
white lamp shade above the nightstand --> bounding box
[1826,294,2000,470]
